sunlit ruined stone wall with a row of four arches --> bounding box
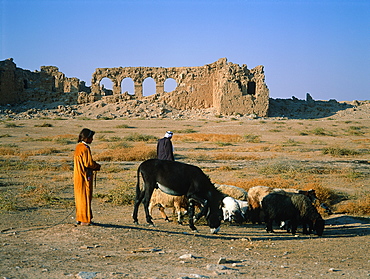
[90,58,269,116]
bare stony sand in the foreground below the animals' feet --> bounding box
[0,201,370,278]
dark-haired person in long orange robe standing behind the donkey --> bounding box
[73,128,100,226]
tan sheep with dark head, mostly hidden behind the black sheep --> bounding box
[248,186,317,224]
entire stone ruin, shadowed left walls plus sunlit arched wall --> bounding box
[0,58,269,117]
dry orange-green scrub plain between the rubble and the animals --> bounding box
[0,117,370,215]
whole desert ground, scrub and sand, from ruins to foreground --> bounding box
[0,99,370,278]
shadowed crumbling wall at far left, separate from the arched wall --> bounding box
[0,58,85,105]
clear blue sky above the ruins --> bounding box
[0,0,370,101]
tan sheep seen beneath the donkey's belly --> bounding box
[148,189,188,224]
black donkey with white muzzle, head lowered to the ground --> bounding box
[132,159,225,233]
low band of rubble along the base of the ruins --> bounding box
[0,98,370,120]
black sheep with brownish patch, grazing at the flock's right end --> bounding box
[262,192,325,236]
